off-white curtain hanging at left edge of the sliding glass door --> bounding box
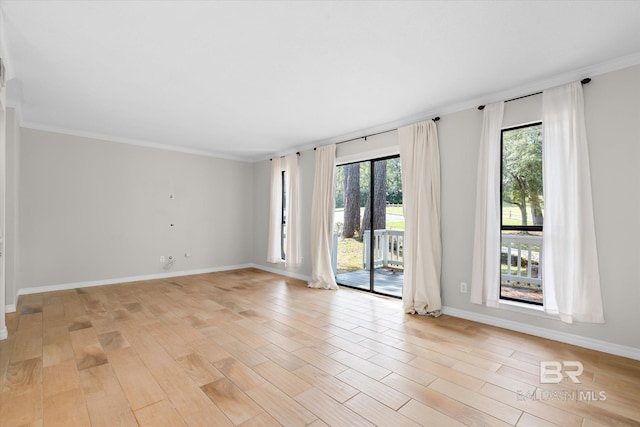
[309,144,338,289]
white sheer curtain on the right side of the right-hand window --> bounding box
[542,82,604,323]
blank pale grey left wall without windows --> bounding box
[19,128,253,289]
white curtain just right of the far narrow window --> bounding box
[284,154,302,267]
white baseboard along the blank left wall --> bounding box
[15,264,253,298]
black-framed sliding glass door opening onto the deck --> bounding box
[333,156,404,297]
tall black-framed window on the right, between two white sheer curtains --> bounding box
[500,123,544,305]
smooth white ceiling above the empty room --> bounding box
[0,0,640,161]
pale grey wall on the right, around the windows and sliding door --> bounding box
[254,66,640,349]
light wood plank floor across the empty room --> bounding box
[0,269,640,427]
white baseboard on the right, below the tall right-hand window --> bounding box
[442,307,640,360]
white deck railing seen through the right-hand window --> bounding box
[500,234,542,286]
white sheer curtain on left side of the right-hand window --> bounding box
[471,101,504,307]
